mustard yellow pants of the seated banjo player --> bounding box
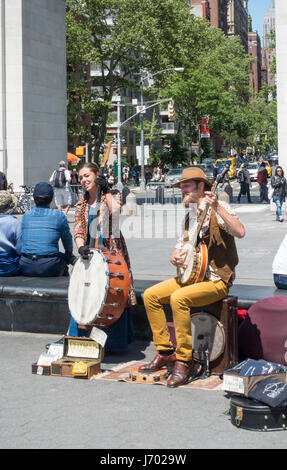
[143,278,228,361]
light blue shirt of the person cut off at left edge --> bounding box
[0,214,22,257]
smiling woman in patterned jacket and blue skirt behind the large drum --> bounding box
[69,163,136,351]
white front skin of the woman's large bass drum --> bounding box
[68,248,109,325]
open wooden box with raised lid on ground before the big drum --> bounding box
[51,336,103,379]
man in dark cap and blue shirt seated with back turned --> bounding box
[20,183,75,277]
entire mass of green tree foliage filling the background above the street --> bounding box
[66,0,277,163]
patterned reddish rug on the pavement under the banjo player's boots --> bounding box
[91,361,222,391]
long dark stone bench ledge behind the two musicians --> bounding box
[0,276,287,338]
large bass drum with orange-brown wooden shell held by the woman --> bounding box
[68,248,131,328]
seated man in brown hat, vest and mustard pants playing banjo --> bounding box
[139,167,245,387]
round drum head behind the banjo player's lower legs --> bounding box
[191,312,225,362]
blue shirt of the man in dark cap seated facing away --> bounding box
[22,206,73,255]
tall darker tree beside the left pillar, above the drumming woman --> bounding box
[67,0,196,159]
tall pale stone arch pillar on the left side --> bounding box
[0,0,67,189]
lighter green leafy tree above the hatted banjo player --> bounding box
[159,20,253,156]
